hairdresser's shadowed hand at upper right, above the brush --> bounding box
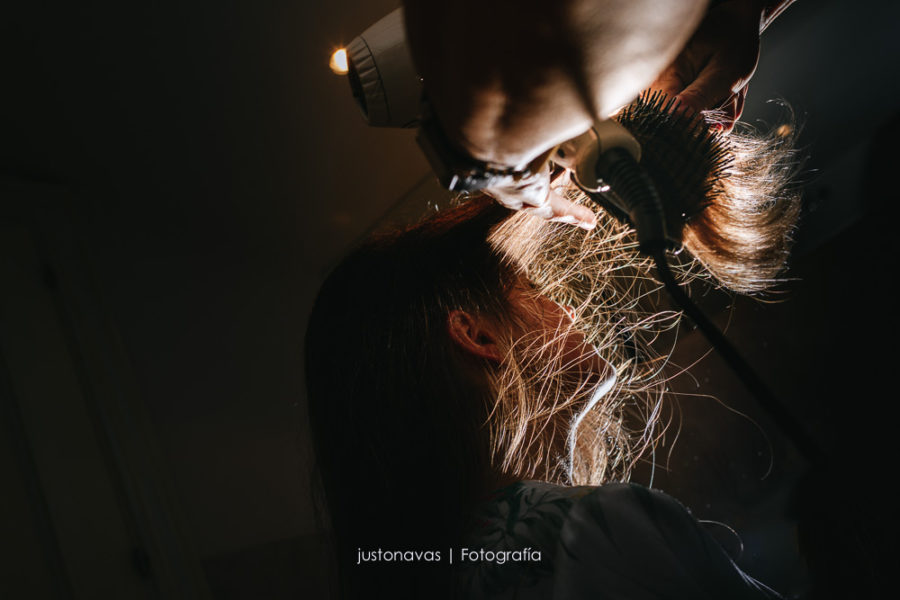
[650,0,794,131]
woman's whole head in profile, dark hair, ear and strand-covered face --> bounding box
[305,199,628,584]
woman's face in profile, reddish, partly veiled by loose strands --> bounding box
[509,284,616,387]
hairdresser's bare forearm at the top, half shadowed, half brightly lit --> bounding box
[404,0,706,165]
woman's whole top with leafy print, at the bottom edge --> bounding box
[458,481,779,600]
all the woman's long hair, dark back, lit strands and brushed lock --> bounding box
[305,105,798,597]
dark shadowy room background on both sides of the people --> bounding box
[0,0,900,598]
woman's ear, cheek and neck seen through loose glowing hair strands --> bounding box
[448,272,616,483]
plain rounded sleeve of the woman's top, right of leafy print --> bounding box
[554,484,780,600]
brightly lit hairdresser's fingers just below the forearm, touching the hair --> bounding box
[484,155,597,229]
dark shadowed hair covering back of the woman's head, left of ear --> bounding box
[306,200,515,597]
